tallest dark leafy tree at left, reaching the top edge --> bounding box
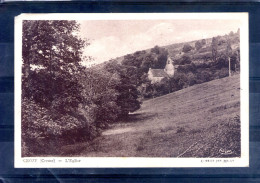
[22,20,85,113]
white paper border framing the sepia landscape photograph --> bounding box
[14,12,249,168]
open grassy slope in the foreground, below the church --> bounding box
[66,75,240,157]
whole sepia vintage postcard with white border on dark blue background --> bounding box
[15,13,249,168]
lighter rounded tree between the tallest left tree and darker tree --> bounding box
[81,68,121,129]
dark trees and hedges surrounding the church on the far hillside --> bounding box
[118,31,240,99]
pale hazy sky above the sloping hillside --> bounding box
[79,20,240,65]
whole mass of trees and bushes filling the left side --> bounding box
[22,20,140,156]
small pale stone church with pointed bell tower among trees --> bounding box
[148,56,175,84]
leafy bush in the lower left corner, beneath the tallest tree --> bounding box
[22,98,95,156]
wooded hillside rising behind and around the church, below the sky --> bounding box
[90,31,240,100]
